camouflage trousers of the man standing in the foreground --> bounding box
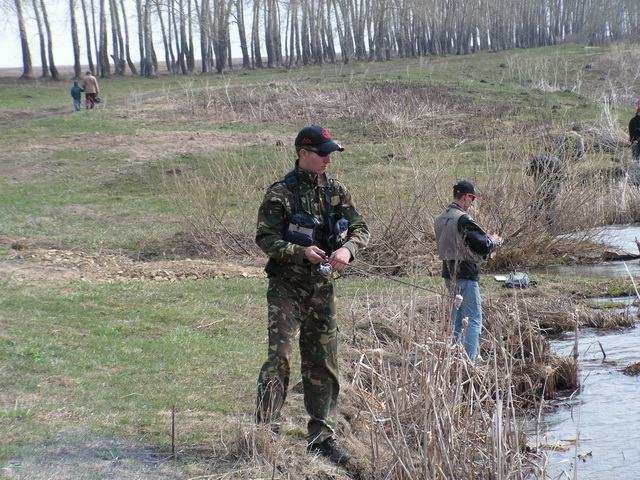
[256,277,340,443]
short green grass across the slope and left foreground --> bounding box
[0,45,640,478]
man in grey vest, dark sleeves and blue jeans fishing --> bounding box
[434,180,502,364]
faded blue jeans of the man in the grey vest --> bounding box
[446,279,482,364]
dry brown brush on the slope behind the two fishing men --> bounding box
[159,69,640,274]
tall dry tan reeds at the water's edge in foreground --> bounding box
[330,284,577,479]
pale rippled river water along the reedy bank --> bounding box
[530,224,640,480]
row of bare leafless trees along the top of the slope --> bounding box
[7,0,640,78]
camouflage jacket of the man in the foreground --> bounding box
[256,163,369,281]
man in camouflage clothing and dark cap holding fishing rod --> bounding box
[256,125,369,463]
